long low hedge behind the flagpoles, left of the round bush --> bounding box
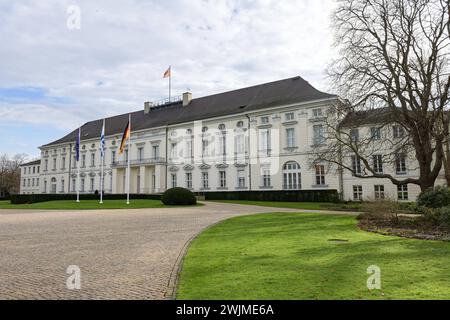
[10,193,161,204]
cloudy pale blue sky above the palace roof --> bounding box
[0,0,335,158]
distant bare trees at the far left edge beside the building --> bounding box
[0,154,26,195]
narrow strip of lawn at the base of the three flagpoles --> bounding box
[0,199,178,210]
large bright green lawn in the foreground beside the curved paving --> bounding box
[177,213,450,299]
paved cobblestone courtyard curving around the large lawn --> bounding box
[0,203,306,299]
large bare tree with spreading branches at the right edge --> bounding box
[315,0,450,190]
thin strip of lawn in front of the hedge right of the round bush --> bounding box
[214,200,361,211]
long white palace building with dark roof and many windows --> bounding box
[21,77,442,201]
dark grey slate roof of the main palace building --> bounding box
[43,77,336,147]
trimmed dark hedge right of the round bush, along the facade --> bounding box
[197,190,339,202]
